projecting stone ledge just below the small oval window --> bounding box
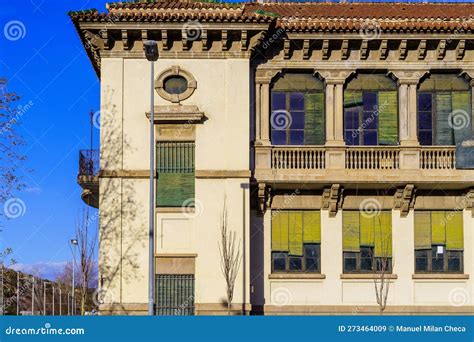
[145,105,205,124]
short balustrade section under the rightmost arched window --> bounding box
[420,146,456,170]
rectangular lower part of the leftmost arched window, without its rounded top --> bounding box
[270,91,326,145]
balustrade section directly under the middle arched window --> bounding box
[346,146,400,170]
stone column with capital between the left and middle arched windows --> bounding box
[315,70,353,169]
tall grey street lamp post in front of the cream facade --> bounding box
[143,40,158,316]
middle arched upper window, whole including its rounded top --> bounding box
[344,74,398,145]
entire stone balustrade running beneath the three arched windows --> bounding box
[270,146,456,171]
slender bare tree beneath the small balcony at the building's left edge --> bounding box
[76,207,97,315]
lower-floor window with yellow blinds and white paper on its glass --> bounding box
[415,210,464,273]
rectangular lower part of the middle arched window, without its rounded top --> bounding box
[344,90,398,146]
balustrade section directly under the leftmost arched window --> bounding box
[271,146,325,170]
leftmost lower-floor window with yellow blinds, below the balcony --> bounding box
[272,210,321,273]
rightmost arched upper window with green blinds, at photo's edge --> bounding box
[418,74,471,145]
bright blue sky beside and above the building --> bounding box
[0,0,472,278]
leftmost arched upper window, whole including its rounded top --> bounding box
[270,73,326,145]
